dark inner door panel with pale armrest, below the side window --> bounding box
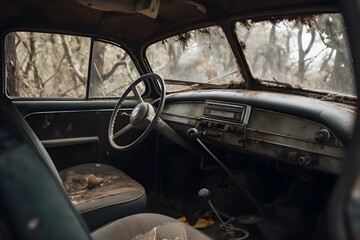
[14,101,156,187]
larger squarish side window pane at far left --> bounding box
[5,32,91,98]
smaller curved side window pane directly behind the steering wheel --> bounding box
[90,41,145,98]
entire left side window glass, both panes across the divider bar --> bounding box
[4,32,145,99]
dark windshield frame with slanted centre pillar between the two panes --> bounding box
[141,7,357,105]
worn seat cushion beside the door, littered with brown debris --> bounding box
[60,163,146,230]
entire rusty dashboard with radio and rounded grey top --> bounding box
[161,91,356,174]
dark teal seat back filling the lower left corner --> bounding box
[0,96,91,240]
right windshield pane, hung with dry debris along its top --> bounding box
[235,14,356,96]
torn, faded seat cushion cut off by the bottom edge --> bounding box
[91,213,211,240]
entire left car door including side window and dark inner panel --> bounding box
[5,32,155,188]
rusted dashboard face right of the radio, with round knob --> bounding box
[245,109,345,174]
